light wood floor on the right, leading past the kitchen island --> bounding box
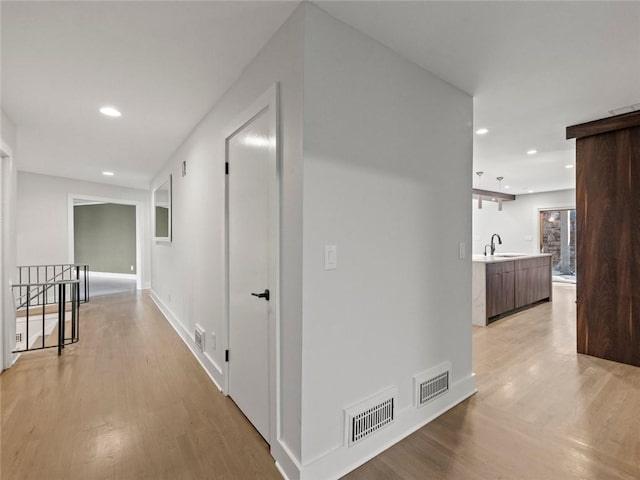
[346,285,640,480]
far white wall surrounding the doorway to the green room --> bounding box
[17,172,151,288]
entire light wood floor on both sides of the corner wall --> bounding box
[0,285,640,480]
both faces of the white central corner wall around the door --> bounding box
[152,4,475,480]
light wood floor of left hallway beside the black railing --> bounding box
[0,294,281,480]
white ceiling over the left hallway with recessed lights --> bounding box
[1,1,296,188]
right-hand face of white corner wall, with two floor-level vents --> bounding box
[302,7,475,478]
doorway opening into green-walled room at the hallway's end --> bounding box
[69,195,142,297]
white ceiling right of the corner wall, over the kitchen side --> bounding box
[319,2,640,194]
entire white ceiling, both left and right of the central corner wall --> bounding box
[2,1,640,194]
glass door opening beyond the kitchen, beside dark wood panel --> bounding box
[540,208,577,283]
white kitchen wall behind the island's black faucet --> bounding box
[471,189,576,254]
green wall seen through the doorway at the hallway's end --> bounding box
[73,203,136,274]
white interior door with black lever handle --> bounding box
[227,110,274,441]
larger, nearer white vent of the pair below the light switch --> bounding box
[345,388,397,447]
